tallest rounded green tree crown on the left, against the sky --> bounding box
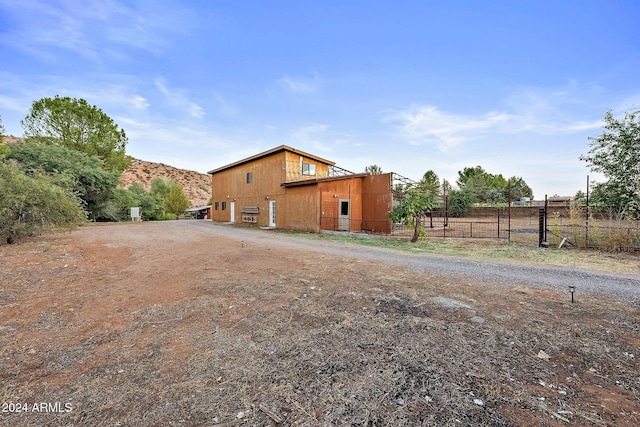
[20,95,129,172]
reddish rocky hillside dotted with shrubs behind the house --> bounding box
[120,159,211,207]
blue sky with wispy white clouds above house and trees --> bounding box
[0,0,640,198]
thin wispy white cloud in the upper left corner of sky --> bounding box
[0,0,194,61]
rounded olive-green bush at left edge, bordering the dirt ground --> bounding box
[0,161,85,243]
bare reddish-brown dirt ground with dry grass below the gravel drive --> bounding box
[0,221,640,426]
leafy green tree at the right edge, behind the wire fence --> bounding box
[580,110,640,219]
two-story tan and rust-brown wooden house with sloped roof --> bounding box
[208,145,393,233]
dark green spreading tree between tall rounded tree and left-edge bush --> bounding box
[10,141,118,219]
